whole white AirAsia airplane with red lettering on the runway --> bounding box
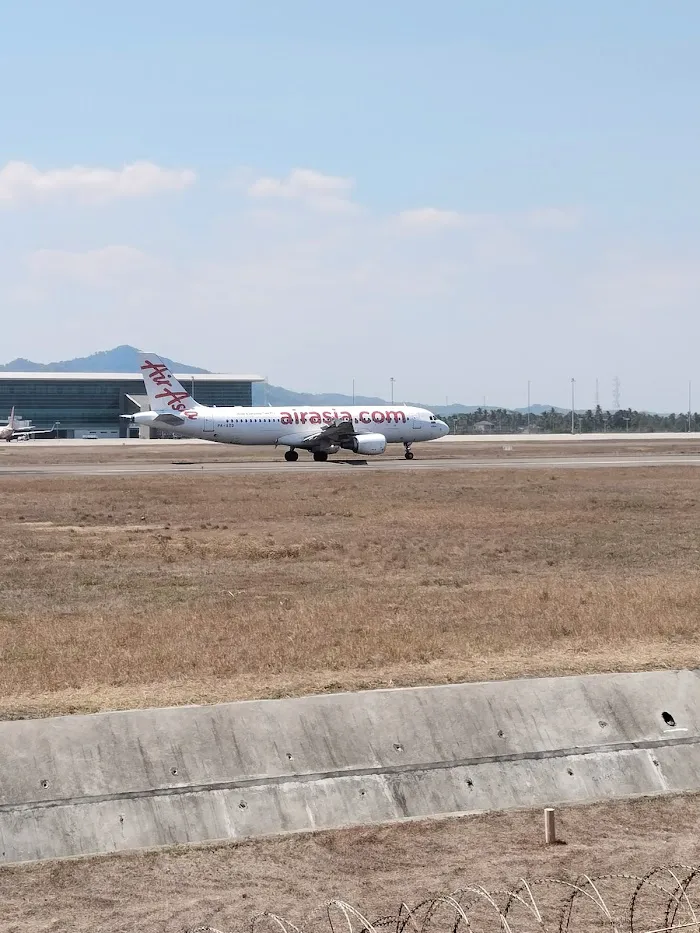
[121,353,449,462]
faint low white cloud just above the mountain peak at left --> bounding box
[28,246,159,288]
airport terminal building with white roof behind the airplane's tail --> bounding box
[0,372,264,437]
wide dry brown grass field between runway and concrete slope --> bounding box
[0,462,700,718]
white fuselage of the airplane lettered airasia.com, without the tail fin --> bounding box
[132,405,447,447]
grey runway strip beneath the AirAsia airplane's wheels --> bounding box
[0,454,700,476]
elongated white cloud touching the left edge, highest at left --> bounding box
[0,162,196,205]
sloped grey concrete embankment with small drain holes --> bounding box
[0,671,700,861]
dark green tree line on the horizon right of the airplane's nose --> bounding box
[443,405,700,434]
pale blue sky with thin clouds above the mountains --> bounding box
[0,0,700,408]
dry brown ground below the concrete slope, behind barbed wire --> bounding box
[0,796,700,933]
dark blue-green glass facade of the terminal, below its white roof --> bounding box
[0,373,253,437]
